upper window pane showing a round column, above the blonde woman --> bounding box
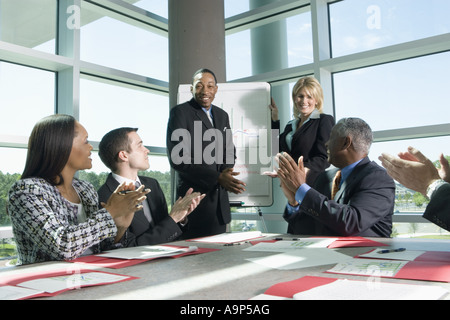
[225,11,313,80]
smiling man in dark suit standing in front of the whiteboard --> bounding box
[167,69,245,239]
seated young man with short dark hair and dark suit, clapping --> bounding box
[98,128,204,247]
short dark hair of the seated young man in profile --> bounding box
[98,127,138,172]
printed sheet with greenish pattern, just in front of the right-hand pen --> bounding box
[328,259,408,277]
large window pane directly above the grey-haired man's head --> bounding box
[334,52,450,131]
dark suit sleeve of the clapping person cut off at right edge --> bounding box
[423,183,450,231]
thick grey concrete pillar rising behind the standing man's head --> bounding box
[169,0,226,108]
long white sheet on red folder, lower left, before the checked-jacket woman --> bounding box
[17,272,129,293]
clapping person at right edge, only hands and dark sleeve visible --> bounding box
[379,147,450,231]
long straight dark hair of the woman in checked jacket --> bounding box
[21,114,76,186]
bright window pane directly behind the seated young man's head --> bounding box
[80,78,169,148]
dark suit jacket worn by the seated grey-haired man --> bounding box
[284,158,395,237]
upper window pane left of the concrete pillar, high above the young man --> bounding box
[80,2,169,81]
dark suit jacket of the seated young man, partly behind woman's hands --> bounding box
[98,174,183,247]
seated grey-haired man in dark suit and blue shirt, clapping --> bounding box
[278,118,395,237]
